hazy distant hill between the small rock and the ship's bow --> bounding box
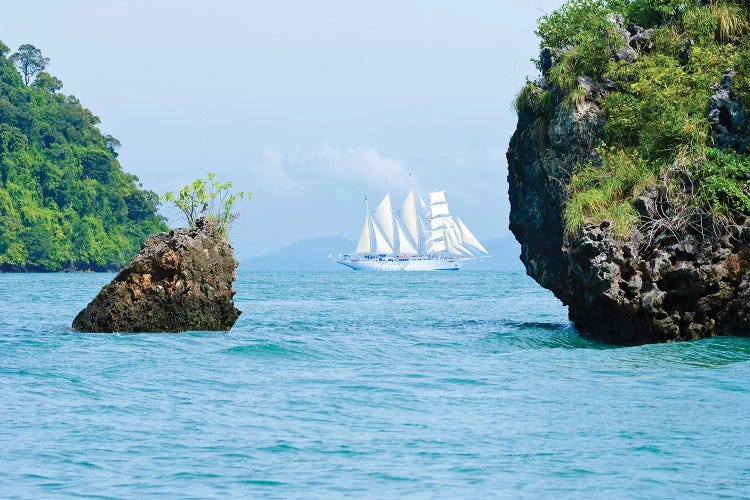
[240,236,357,271]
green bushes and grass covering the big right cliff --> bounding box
[516,0,750,236]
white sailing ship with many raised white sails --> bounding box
[336,184,490,271]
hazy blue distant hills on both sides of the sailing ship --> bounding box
[240,235,524,271]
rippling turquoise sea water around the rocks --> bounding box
[0,271,750,498]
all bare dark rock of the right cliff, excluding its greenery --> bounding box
[507,42,750,345]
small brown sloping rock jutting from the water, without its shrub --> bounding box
[73,220,240,332]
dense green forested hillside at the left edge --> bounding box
[0,42,167,271]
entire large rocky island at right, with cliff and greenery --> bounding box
[507,0,750,345]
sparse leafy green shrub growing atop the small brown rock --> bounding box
[164,172,253,236]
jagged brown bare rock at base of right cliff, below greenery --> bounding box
[564,224,750,345]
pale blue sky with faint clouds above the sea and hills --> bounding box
[0,0,562,258]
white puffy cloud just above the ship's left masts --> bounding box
[313,144,408,185]
